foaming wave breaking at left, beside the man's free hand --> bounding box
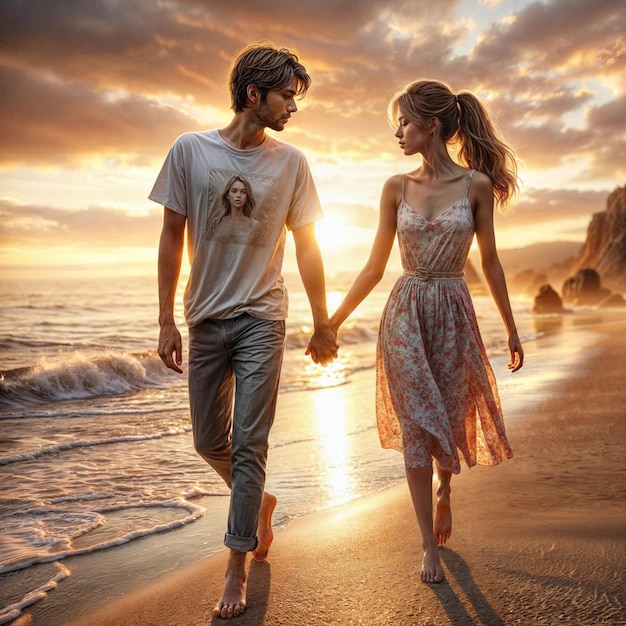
[0,352,177,409]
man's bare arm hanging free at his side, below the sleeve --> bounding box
[158,208,187,374]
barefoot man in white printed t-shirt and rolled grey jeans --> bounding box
[150,45,337,618]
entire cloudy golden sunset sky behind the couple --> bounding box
[0,0,626,275]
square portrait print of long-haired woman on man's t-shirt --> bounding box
[205,170,274,247]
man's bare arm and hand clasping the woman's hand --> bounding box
[293,223,338,365]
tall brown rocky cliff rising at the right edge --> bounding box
[571,186,626,292]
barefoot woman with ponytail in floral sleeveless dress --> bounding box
[331,80,523,583]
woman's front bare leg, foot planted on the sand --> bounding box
[406,465,444,583]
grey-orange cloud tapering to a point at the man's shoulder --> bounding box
[0,68,200,166]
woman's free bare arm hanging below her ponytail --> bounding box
[470,172,524,372]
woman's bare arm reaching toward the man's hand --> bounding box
[330,176,402,331]
